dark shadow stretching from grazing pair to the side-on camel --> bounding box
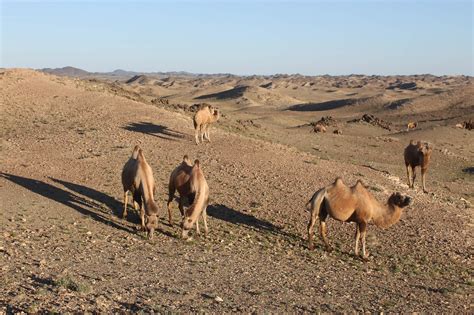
[207,204,301,240]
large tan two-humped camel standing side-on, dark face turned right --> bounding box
[306,177,411,260]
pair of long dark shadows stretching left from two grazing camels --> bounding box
[0,172,138,233]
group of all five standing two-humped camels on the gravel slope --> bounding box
[122,105,433,260]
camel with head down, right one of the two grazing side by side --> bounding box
[168,155,209,239]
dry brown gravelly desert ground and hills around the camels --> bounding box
[0,69,474,313]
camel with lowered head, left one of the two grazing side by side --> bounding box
[122,145,158,239]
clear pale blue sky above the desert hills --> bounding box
[0,0,474,76]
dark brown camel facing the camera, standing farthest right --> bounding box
[403,140,433,193]
